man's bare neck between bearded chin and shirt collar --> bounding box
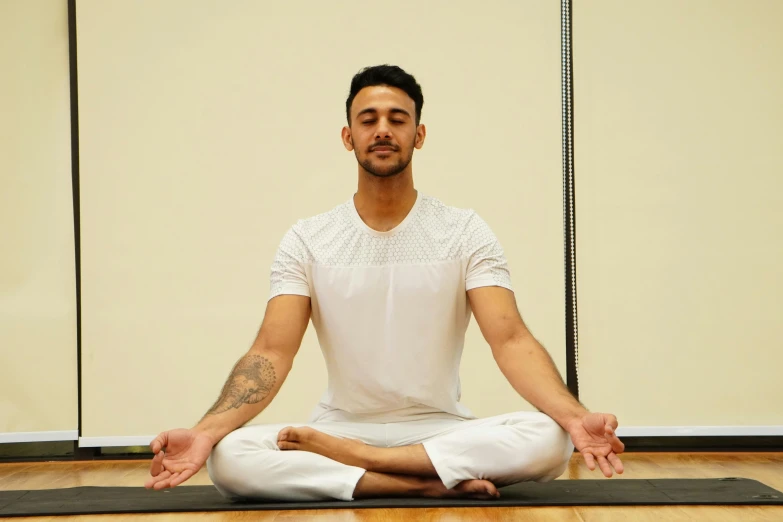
[353,167,417,232]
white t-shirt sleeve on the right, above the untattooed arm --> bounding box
[465,213,514,292]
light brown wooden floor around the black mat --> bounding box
[0,453,783,522]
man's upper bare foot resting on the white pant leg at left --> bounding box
[277,426,370,469]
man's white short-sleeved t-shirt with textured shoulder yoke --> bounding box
[269,192,513,423]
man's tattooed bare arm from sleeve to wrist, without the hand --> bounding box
[193,295,311,444]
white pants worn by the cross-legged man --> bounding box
[207,412,574,501]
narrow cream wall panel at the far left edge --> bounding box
[0,0,77,436]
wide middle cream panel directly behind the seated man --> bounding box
[77,0,565,437]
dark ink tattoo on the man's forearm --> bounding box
[206,354,276,415]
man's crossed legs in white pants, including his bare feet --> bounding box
[207,412,573,501]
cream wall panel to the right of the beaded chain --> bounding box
[573,0,783,431]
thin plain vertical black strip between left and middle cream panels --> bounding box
[68,0,82,447]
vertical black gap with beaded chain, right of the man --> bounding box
[560,0,579,398]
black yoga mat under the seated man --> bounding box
[0,477,783,517]
